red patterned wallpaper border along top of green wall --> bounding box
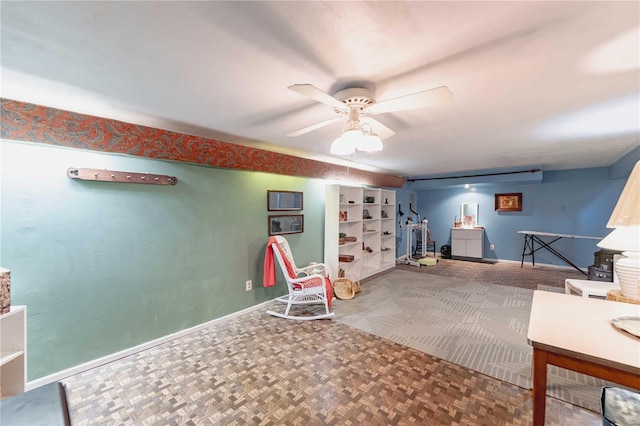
[0,98,406,188]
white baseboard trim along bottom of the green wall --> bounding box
[26,299,275,391]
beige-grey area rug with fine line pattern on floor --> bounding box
[334,269,607,412]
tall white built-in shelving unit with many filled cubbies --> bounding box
[324,185,396,280]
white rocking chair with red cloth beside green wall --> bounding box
[267,236,335,320]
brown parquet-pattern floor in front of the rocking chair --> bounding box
[64,262,601,426]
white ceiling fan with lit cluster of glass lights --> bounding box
[287,84,451,155]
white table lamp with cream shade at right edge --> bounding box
[598,161,640,300]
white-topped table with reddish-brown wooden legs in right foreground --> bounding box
[527,290,640,426]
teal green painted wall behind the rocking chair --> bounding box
[0,140,325,380]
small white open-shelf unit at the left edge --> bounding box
[0,306,27,398]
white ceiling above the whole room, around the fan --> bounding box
[0,1,640,177]
